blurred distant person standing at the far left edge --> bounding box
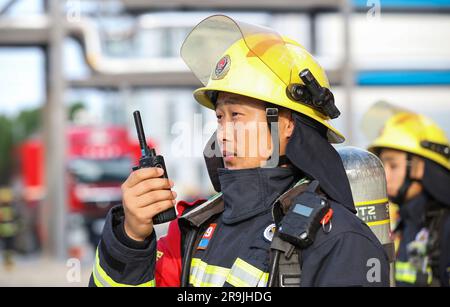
[0,188,17,270]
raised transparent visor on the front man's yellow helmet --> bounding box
[181,15,298,86]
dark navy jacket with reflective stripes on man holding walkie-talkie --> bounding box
[90,171,389,286]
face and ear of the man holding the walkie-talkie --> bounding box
[216,92,294,169]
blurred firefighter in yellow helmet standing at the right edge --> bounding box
[369,107,450,287]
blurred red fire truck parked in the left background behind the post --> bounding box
[18,126,143,255]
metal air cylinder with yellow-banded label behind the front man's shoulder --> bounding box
[337,147,395,283]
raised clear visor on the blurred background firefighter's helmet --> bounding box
[361,101,411,143]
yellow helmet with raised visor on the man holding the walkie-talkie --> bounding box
[181,15,345,143]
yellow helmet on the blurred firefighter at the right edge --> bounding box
[369,111,450,170]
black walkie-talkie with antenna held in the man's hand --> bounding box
[133,111,177,225]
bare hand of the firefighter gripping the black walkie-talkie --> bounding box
[122,167,177,241]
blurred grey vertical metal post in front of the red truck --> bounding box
[41,0,67,260]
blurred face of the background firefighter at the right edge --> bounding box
[380,149,424,199]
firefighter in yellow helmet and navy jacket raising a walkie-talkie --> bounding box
[90,15,389,287]
